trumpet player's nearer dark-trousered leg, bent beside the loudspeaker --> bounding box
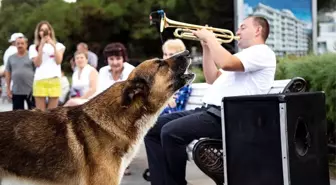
[161,111,222,185]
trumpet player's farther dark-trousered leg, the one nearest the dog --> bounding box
[145,109,202,185]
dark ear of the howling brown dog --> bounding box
[121,79,149,107]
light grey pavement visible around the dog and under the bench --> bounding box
[0,103,336,185]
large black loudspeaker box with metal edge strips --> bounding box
[222,92,330,185]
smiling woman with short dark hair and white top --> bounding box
[98,42,134,93]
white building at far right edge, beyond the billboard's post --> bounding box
[317,22,336,54]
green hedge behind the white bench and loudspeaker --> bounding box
[276,53,336,143]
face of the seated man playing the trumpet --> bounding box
[236,17,257,49]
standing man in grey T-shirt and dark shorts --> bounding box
[5,36,35,110]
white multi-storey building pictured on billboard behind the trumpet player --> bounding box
[251,3,311,56]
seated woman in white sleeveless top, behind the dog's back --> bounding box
[64,51,98,106]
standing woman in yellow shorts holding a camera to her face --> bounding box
[29,21,65,111]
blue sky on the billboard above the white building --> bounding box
[244,0,312,22]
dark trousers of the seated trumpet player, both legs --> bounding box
[145,106,222,185]
